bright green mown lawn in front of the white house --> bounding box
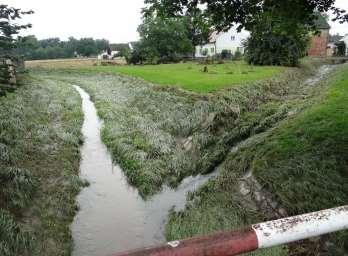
[87,61,285,93]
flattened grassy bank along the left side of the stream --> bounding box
[0,78,83,256]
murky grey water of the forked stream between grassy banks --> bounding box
[72,86,216,256]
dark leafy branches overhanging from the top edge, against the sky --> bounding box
[144,0,348,31]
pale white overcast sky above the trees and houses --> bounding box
[2,0,348,43]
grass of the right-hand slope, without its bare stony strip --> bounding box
[167,65,348,255]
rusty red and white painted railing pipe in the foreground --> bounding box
[114,205,348,256]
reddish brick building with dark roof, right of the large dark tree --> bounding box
[308,15,330,57]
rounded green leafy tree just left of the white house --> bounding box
[135,16,193,63]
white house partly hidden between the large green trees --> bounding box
[195,27,249,58]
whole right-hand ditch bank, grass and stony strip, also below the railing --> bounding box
[166,65,348,256]
